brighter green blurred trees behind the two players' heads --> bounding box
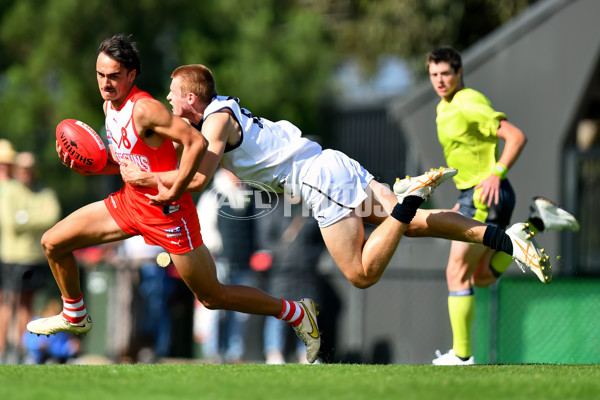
[0,0,336,216]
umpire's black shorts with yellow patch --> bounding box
[457,179,516,229]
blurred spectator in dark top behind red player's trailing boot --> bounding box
[256,193,325,364]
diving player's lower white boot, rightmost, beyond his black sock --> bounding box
[506,222,552,283]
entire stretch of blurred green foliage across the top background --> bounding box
[0,0,534,212]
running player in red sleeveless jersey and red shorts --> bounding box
[27,34,320,362]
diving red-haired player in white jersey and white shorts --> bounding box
[121,64,549,294]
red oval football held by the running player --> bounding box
[56,119,108,172]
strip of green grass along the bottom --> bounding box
[0,364,600,400]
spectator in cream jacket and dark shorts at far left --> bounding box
[0,152,61,361]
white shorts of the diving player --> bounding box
[300,149,373,228]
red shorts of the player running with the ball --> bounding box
[104,186,203,254]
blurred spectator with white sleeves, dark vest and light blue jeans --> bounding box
[194,169,255,363]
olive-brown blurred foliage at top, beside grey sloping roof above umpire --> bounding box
[326,0,537,73]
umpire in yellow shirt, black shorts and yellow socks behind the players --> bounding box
[427,47,527,365]
